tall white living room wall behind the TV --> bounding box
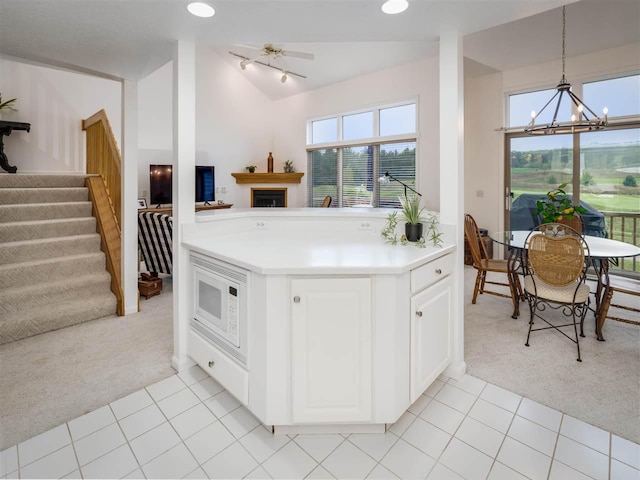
[138,47,274,207]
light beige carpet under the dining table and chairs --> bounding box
[464,267,640,443]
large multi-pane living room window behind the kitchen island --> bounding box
[307,102,417,208]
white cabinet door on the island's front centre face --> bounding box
[291,278,372,423]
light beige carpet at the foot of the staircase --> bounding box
[0,276,175,451]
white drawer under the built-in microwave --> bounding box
[188,331,249,405]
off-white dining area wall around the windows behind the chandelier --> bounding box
[465,44,640,237]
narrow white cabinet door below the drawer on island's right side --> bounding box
[411,277,452,403]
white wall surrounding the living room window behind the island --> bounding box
[272,56,440,210]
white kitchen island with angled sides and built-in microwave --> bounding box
[181,209,461,433]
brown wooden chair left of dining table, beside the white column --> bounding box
[464,214,523,318]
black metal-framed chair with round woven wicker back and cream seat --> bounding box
[524,223,589,362]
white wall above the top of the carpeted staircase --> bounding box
[0,58,122,173]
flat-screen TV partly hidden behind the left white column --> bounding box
[149,165,216,207]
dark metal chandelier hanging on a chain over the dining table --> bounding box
[524,6,608,135]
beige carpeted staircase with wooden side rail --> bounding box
[0,174,116,344]
